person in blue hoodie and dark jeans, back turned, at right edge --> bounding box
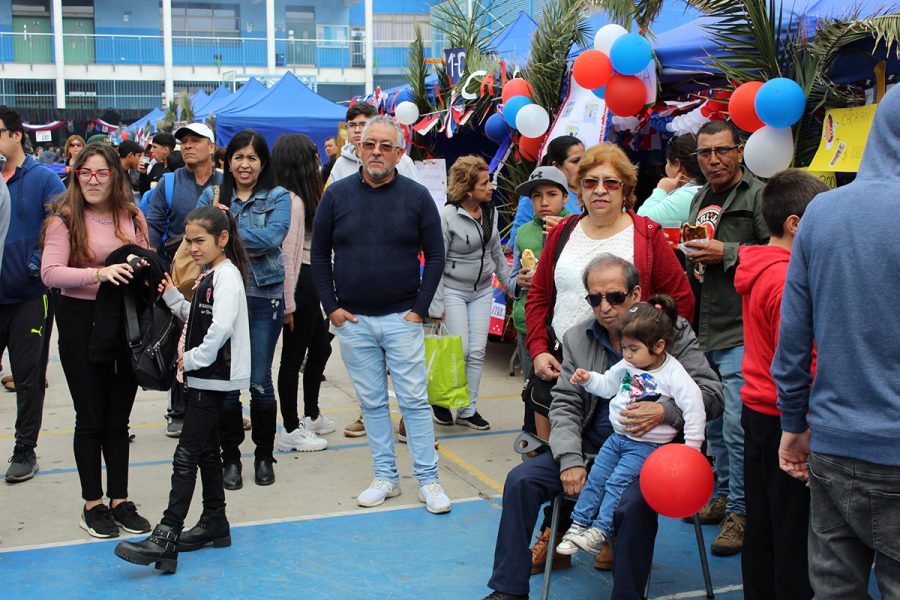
[772,86,900,600]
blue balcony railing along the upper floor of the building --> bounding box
[0,27,432,71]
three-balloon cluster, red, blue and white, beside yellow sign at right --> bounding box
[728,77,806,177]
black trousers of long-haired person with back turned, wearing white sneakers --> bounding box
[278,265,331,431]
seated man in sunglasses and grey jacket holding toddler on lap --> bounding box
[487,253,723,600]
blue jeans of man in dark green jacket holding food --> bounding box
[706,346,747,515]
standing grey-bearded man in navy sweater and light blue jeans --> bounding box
[311,117,451,513]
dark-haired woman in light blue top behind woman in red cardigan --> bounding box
[638,133,705,225]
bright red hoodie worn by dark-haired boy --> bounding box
[734,246,815,416]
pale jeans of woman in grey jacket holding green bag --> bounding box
[444,286,494,418]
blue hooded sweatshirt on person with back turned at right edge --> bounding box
[772,86,900,466]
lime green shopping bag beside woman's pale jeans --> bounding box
[425,323,469,408]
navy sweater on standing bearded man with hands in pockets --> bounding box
[310,175,444,317]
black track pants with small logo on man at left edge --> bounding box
[0,294,53,448]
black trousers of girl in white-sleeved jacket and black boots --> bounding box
[162,388,228,530]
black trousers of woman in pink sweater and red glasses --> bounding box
[56,296,137,500]
